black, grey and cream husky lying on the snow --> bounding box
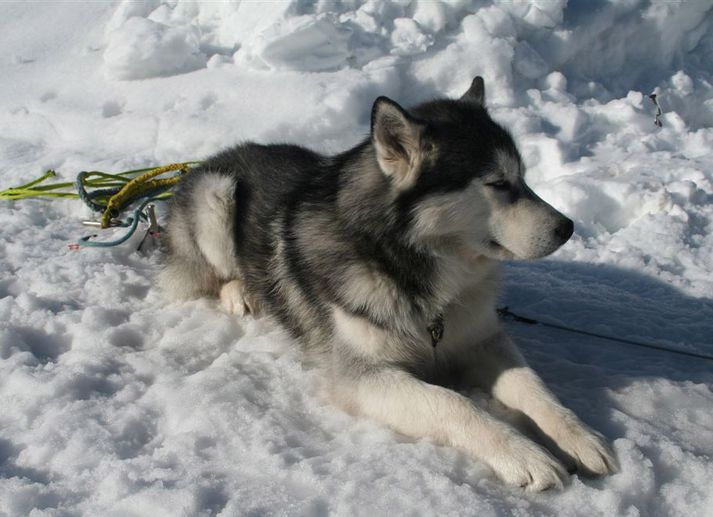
[161,77,617,490]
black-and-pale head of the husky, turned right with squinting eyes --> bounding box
[371,77,573,259]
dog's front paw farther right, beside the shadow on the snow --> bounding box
[554,415,619,476]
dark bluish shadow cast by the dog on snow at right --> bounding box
[492,260,713,463]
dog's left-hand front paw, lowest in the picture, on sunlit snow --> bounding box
[489,434,568,491]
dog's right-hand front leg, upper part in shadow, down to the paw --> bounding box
[469,331,618,475]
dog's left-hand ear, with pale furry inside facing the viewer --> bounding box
[371,97,425,188]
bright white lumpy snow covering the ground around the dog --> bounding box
[0,0,713,516]
